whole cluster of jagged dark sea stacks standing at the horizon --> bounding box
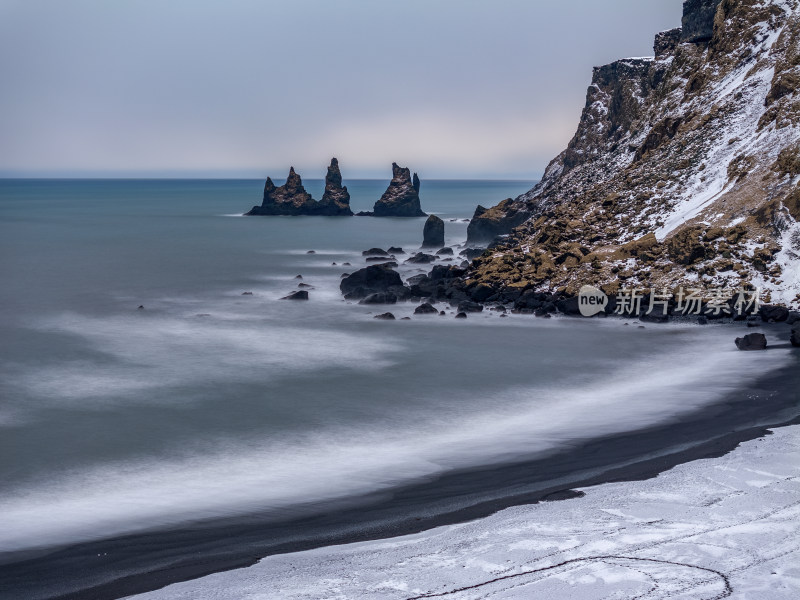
[245,158,427,217]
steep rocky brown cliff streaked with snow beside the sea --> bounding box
[466,0,800,306]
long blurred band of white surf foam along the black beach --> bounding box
[0,334,790,551]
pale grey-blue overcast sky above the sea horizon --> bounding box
[0,0,682,179]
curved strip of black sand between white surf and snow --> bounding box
[0,324,800,600]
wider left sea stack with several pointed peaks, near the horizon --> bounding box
[245,158,353,216]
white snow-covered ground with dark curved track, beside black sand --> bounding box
[135,426,800,600]
